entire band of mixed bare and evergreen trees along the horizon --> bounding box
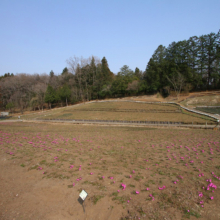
[0,31,220,113]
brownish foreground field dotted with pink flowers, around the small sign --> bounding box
[0,122,220,220]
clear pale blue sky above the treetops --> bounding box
[0,0,220,75]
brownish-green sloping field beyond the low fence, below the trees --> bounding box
[22,102,213,124]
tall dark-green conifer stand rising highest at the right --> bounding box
[144,31,220,92]
